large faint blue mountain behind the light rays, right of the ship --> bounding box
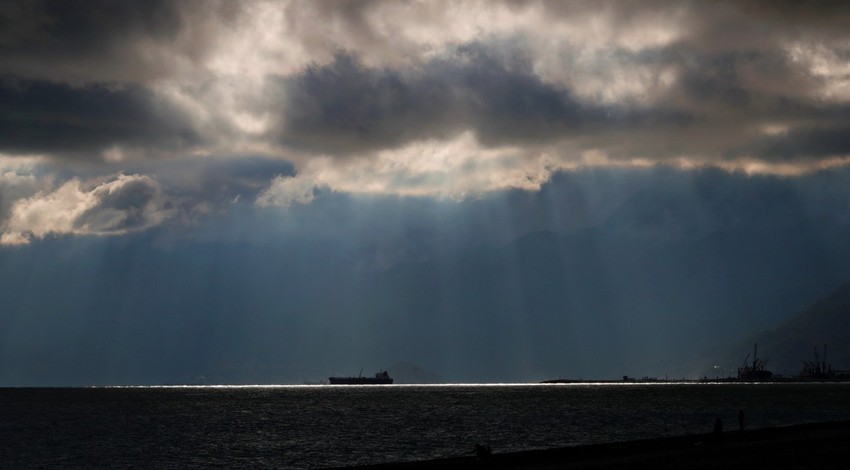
[352,174,850,381]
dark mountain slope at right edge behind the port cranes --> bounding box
[704,282,850,376]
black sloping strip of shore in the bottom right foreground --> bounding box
[342,421,850,469]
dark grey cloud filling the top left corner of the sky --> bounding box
[0,0,240,83]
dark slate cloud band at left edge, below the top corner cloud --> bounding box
[0,77,201,159]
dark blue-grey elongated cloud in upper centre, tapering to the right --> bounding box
[278,48,687,154]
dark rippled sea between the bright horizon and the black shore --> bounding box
[0,383,850,469]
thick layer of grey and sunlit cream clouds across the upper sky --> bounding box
[0,0,850,239]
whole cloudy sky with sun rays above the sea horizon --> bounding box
[0,0,850,385]
